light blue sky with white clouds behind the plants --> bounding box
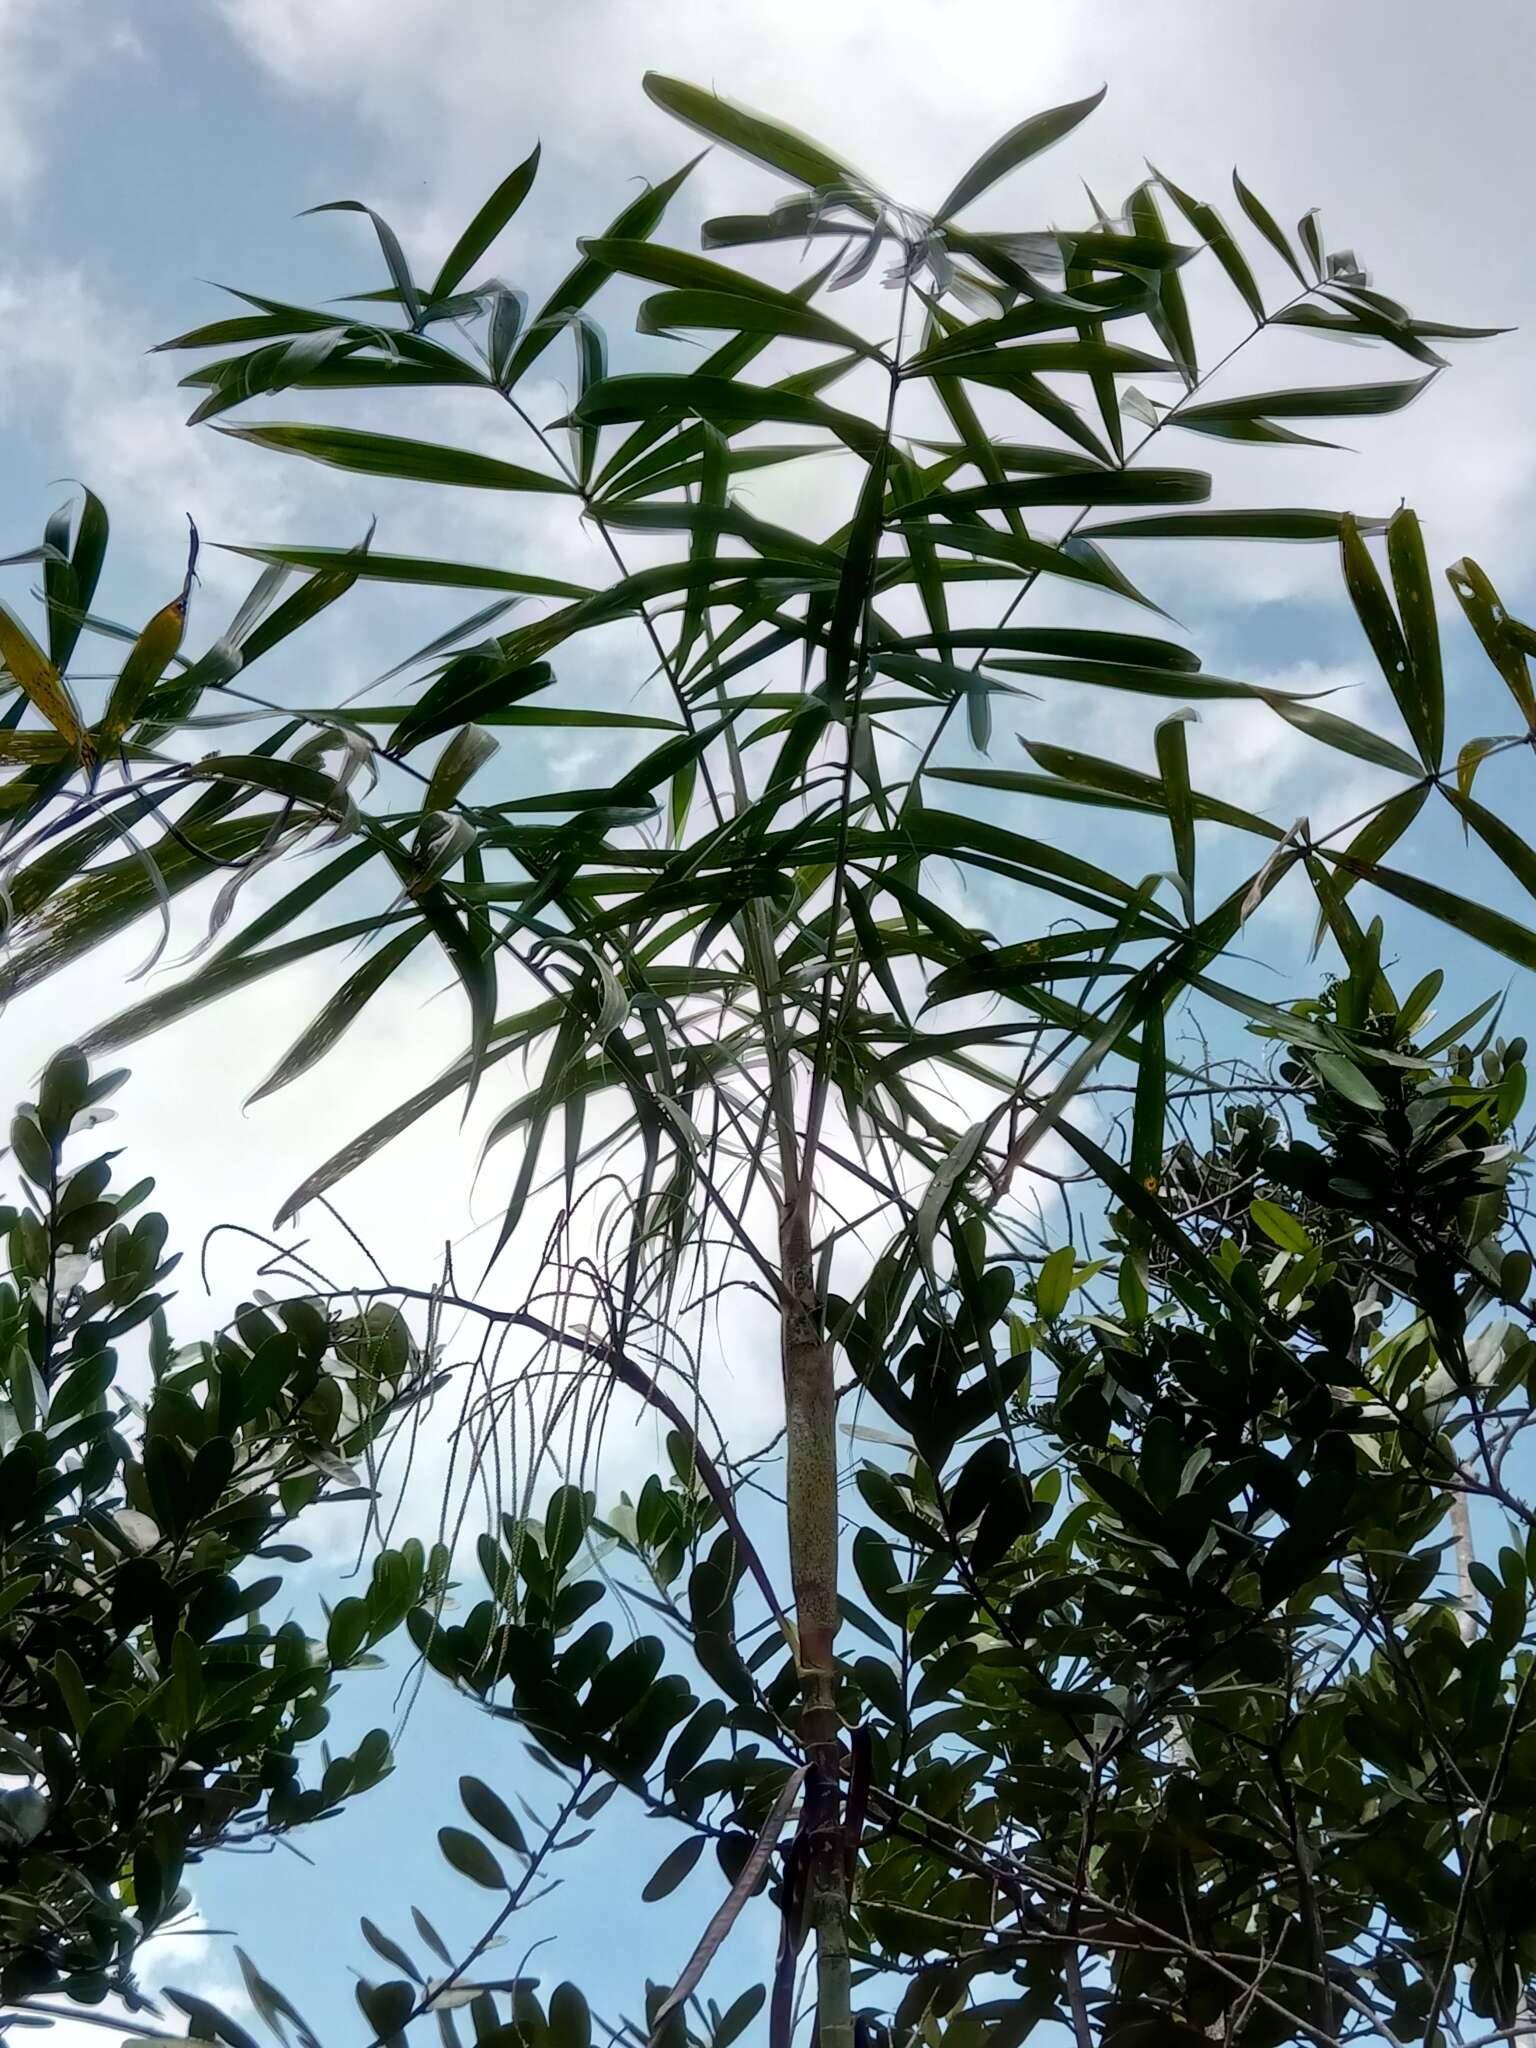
[0,0,1536,2038]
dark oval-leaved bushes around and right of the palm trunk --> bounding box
[296,978,1536,2048]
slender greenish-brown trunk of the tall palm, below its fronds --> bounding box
[780,1188,854,2048]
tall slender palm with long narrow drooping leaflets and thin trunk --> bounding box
[0,64,1536,2048]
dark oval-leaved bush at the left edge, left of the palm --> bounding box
[0,1051,444,2003]
